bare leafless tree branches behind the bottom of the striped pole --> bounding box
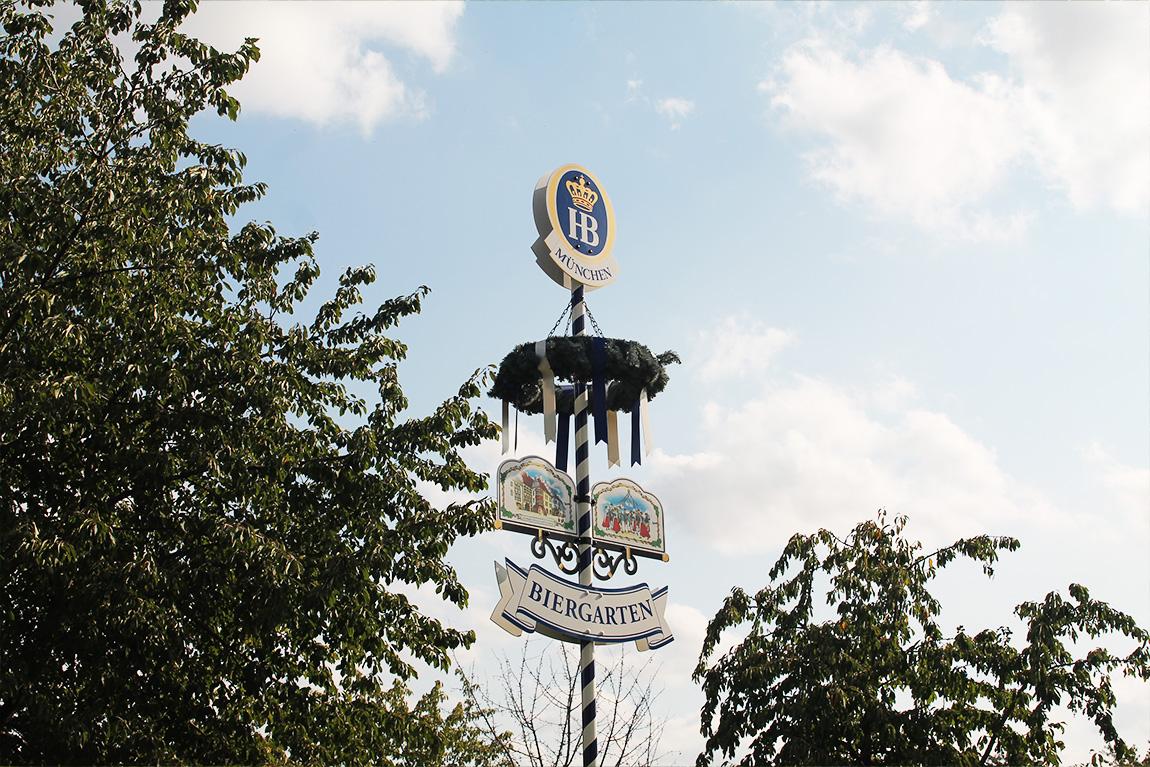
[457,641,666,767]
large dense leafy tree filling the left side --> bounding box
[0,0,498,764]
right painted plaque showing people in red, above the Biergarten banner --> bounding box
[591,480,667,559]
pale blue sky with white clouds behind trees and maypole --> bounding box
[105,2,1150,765]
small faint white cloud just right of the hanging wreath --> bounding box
[693,316,795,383]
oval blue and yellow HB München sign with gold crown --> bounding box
[531,166,619,290]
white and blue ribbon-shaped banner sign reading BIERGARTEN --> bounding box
[491,559,675,652]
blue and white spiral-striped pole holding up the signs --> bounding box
[572,283,599,767]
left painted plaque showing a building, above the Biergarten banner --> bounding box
[496,455,575,537]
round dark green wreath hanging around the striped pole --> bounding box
[488,336,682,414]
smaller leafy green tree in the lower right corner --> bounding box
[695,512,1150,766]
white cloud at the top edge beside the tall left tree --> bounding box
[185,2,462,136]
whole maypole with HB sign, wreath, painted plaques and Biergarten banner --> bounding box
[489,166,679,767]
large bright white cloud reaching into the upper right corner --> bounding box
[760,3,1150,240]
